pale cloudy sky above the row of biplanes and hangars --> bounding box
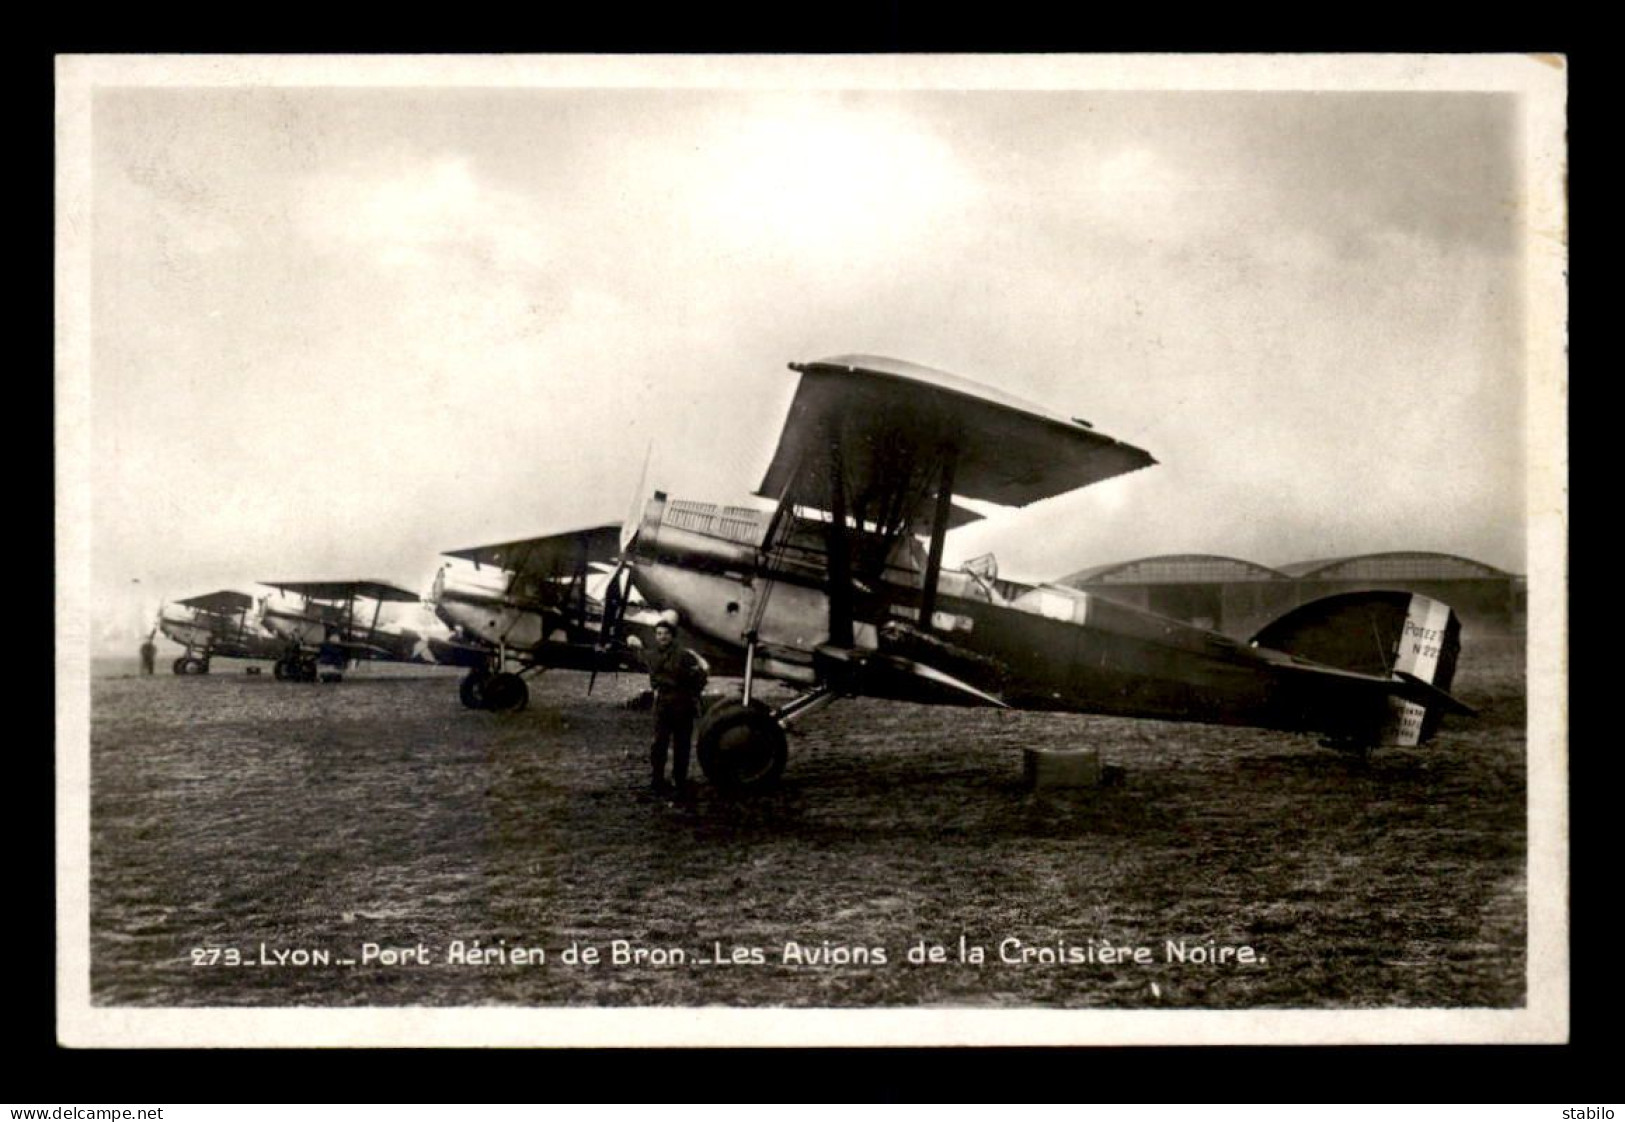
[66,58,1560,646]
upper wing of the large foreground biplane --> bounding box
[757,354,1155,509]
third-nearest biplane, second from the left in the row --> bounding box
[260,581,473,681]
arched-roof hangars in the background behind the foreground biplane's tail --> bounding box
[1058,551,1524,637]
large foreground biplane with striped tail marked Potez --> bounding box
[611,354,1472,790]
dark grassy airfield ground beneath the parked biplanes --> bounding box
[82,644,1526,1008]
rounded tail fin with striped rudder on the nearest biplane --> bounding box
[1253,590,1472,746]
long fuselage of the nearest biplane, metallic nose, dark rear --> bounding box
[634,497,1449,743]
